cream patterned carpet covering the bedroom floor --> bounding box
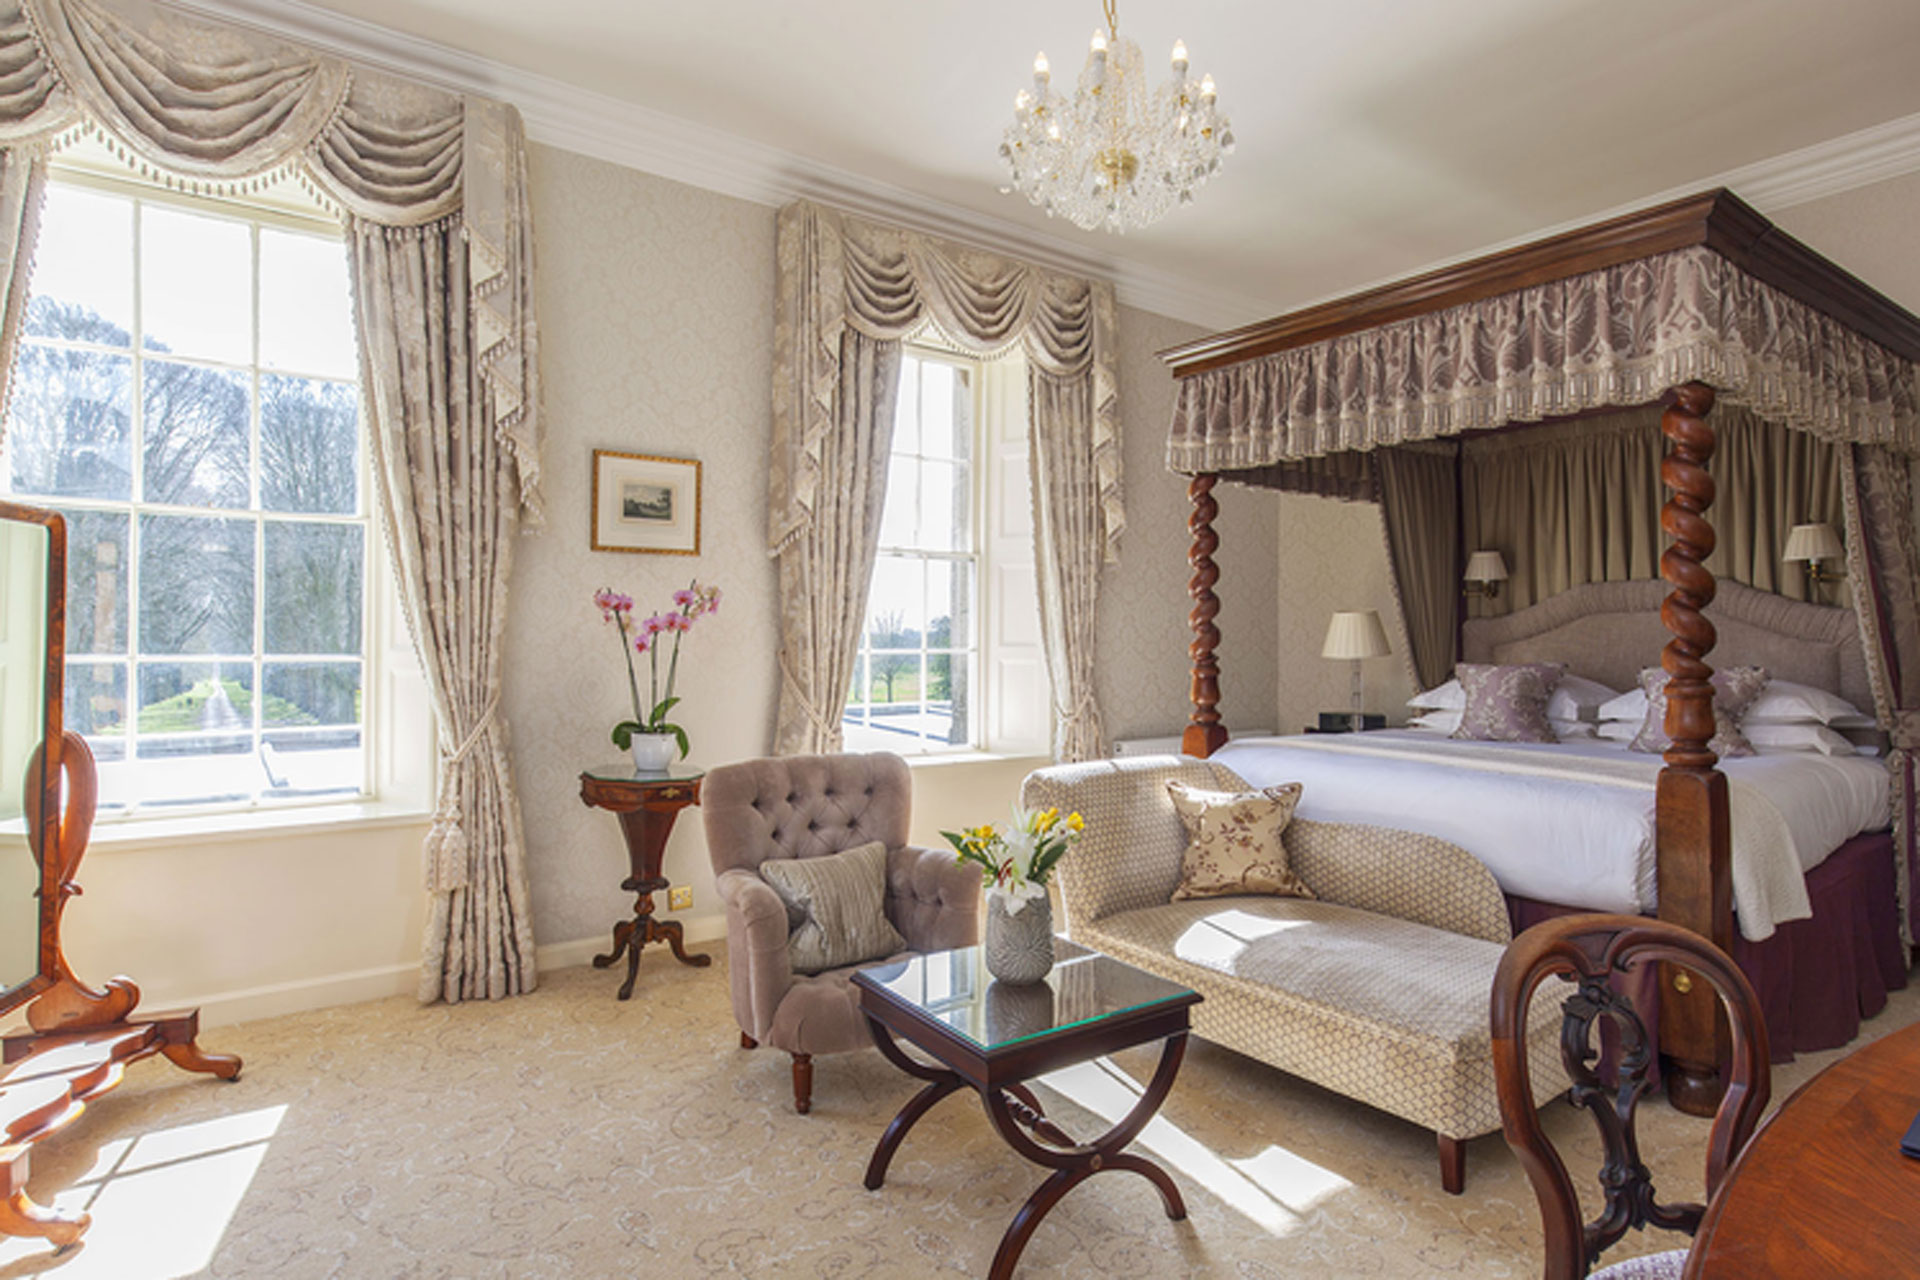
[0,946,1920,1280]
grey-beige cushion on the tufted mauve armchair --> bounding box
[760,841,906,973]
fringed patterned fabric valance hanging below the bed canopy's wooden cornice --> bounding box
[1167,246,1920,474]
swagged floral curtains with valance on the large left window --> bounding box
[0,0,541,1000]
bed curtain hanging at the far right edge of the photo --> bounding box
[1843,445,1920,946]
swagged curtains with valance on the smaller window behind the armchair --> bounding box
[768,201,1125,758]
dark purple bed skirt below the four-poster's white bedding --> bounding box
[1507,831,1907,1063]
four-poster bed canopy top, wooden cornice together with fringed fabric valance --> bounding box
[1164,192,1920,474]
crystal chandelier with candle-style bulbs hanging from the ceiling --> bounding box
[1000,0,1233,232]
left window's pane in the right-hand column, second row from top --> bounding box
[259,374,359,516]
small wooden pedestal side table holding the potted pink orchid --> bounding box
[580,762,714,1000]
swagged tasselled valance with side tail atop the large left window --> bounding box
[0,0,540,524]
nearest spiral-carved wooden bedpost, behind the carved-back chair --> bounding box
[1655,382,1734,1115]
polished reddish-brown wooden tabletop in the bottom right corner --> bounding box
[1686,1025,1920,1280]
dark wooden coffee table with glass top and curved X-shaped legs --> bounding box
[852,938,1200,1280]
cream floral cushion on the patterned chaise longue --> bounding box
[1167,783,1313,902]
